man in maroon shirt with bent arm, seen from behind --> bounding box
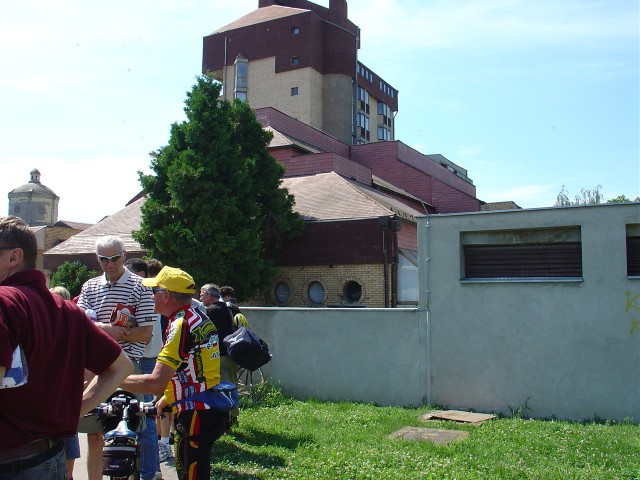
[0,217,133,479]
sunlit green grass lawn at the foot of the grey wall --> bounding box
[212,386,640,480]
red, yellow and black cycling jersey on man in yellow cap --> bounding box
[157,306,220,411]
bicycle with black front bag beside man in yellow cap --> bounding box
[87,390,156,480]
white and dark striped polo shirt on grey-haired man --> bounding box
[78,269,156,358]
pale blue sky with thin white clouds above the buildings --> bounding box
[0,0,640,223]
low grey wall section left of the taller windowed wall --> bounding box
[242,307,427,406]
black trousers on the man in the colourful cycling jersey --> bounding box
[173,410,229,480]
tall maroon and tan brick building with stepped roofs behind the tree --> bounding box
[202,0,480,307]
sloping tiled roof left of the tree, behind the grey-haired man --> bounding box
[45,197,145,255]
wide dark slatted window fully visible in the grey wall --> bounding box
[462,227,582,281]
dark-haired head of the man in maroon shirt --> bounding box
[0,216,38,282]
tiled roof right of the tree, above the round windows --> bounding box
[282,172,420,220]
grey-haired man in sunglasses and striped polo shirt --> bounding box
[78,235,157,480]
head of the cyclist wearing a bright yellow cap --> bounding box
[142,266,196,317]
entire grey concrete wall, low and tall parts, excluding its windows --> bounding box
[243,203,640,421]
